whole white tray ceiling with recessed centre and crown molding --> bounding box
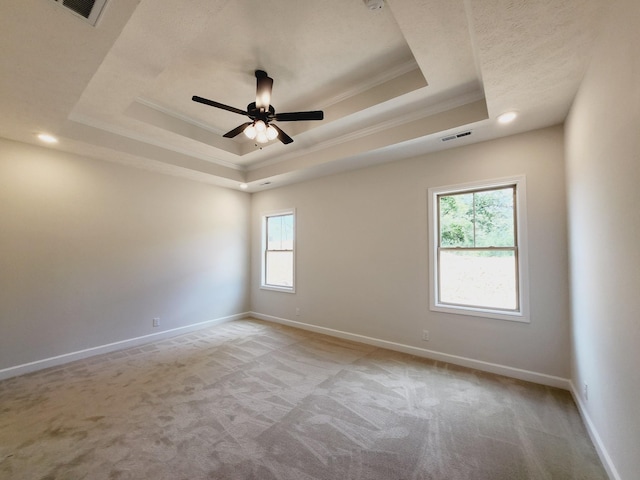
[0,0,612,191]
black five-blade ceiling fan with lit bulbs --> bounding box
[191,70,324,144]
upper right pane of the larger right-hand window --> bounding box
[474,187,515,247]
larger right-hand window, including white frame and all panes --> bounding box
[429,177,528,321]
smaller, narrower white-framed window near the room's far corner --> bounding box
[261,210,295,292]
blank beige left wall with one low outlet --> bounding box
[0,140,250,371]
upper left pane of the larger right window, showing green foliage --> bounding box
[438,193,473,247]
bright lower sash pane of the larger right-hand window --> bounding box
[439,251,518,310]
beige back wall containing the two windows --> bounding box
[251,127,570,379]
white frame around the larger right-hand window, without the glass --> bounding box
[428,175,530,323]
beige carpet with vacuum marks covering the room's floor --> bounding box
[0,320,606,480]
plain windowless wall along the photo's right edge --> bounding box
[566,0,640,480]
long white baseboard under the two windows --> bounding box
[250,312,570,390]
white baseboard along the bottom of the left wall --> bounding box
[0,312,249,380]
